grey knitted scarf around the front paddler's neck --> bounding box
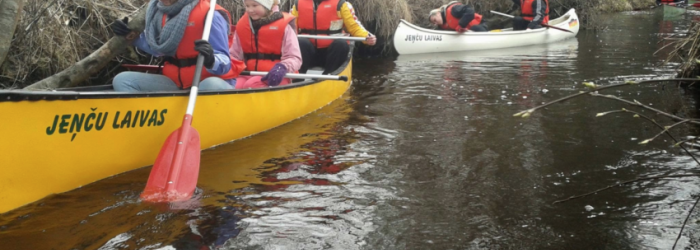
[146,0,199,56]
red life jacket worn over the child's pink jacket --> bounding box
[236,12,294,71]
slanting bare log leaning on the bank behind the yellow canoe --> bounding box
[23,7,146,90]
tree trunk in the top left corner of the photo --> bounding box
[0,0,24,65]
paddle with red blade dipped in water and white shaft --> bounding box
[141,0,216,202]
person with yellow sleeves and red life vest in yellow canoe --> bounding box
[292,0,377,74]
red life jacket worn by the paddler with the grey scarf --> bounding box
[163,0,243,89]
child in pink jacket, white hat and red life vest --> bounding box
[230,0,301,89]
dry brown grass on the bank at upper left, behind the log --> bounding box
[0,0,143,88]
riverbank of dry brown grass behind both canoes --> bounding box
[0,0,654,88]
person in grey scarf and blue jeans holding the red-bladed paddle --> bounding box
[110,0,245,92]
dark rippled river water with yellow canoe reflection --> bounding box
[0,8,700,250]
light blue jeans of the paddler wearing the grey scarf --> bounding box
[112,71,235,92]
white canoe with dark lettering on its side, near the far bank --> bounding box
[394,9,580,55]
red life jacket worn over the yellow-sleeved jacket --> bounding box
[297,0,345,49]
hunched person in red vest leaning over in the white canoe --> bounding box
[428,1,488,32]
